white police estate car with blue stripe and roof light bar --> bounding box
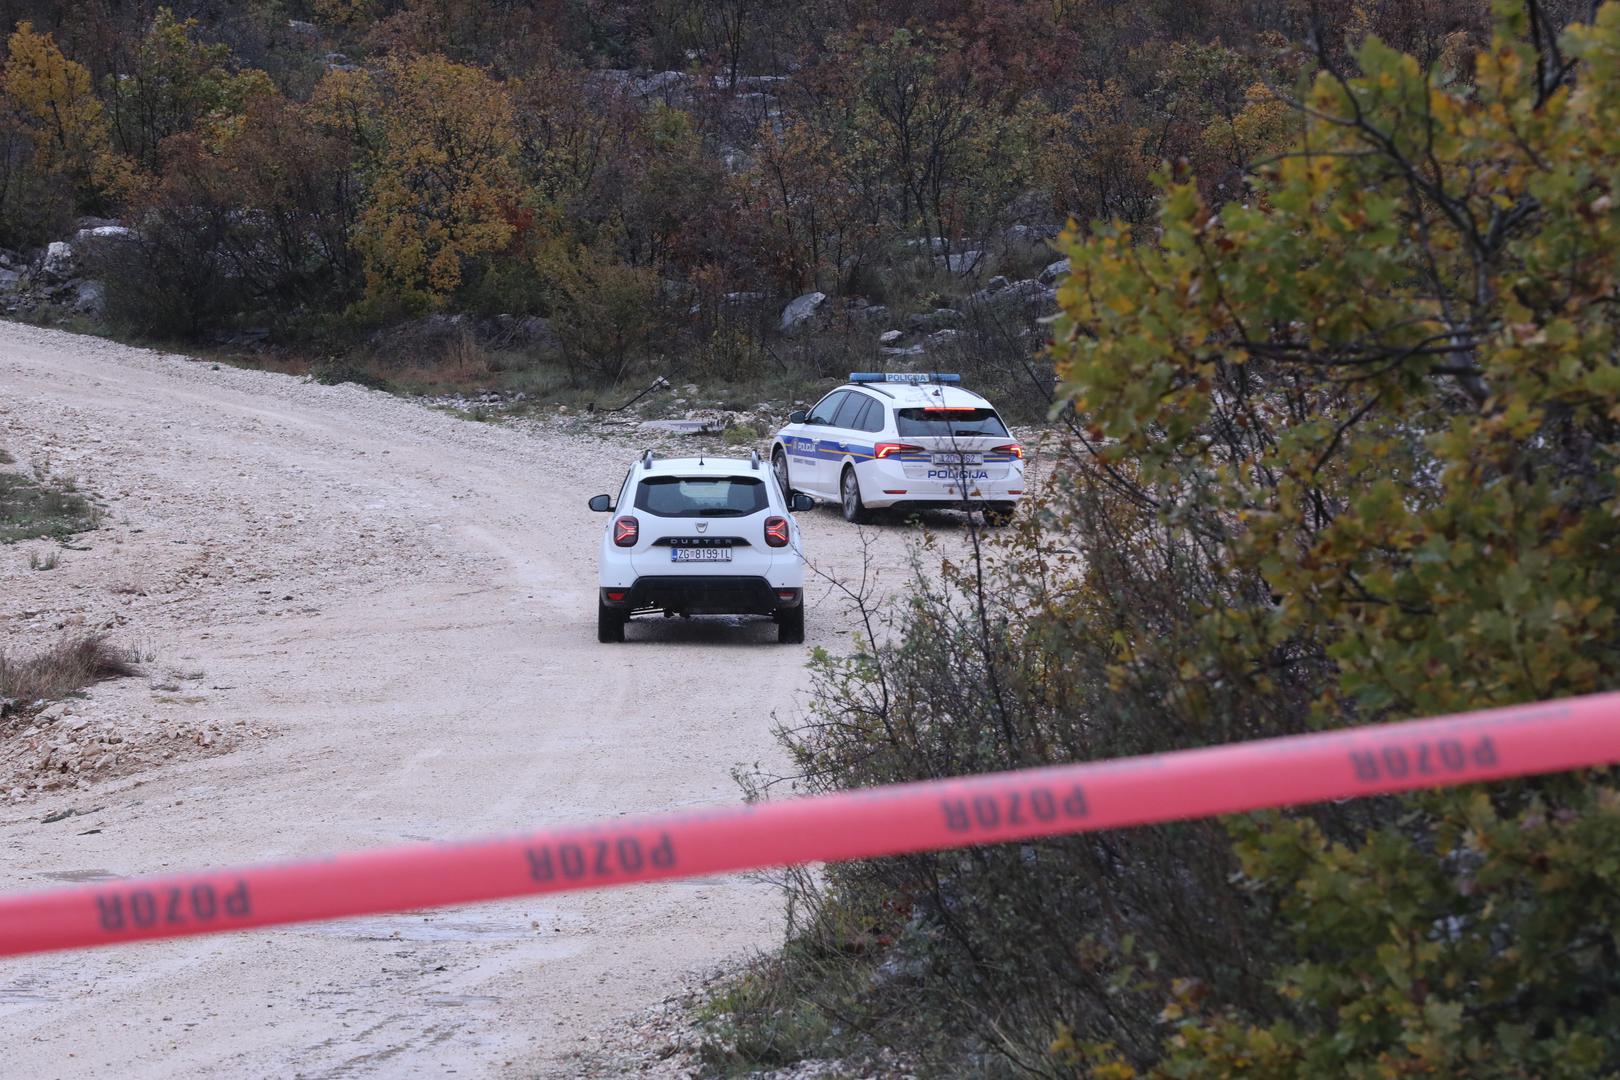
[771,372,1024,521]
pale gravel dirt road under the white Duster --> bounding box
[0,324,933,1077]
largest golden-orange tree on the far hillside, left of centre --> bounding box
[356,55,518,311]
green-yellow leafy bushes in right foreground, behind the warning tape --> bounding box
[708,3,1620,1078]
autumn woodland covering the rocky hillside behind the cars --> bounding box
[0,0,1584,406]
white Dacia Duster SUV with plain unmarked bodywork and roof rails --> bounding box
[590,450,815,644]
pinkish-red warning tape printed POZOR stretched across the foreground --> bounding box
[0,693,1620,955]
